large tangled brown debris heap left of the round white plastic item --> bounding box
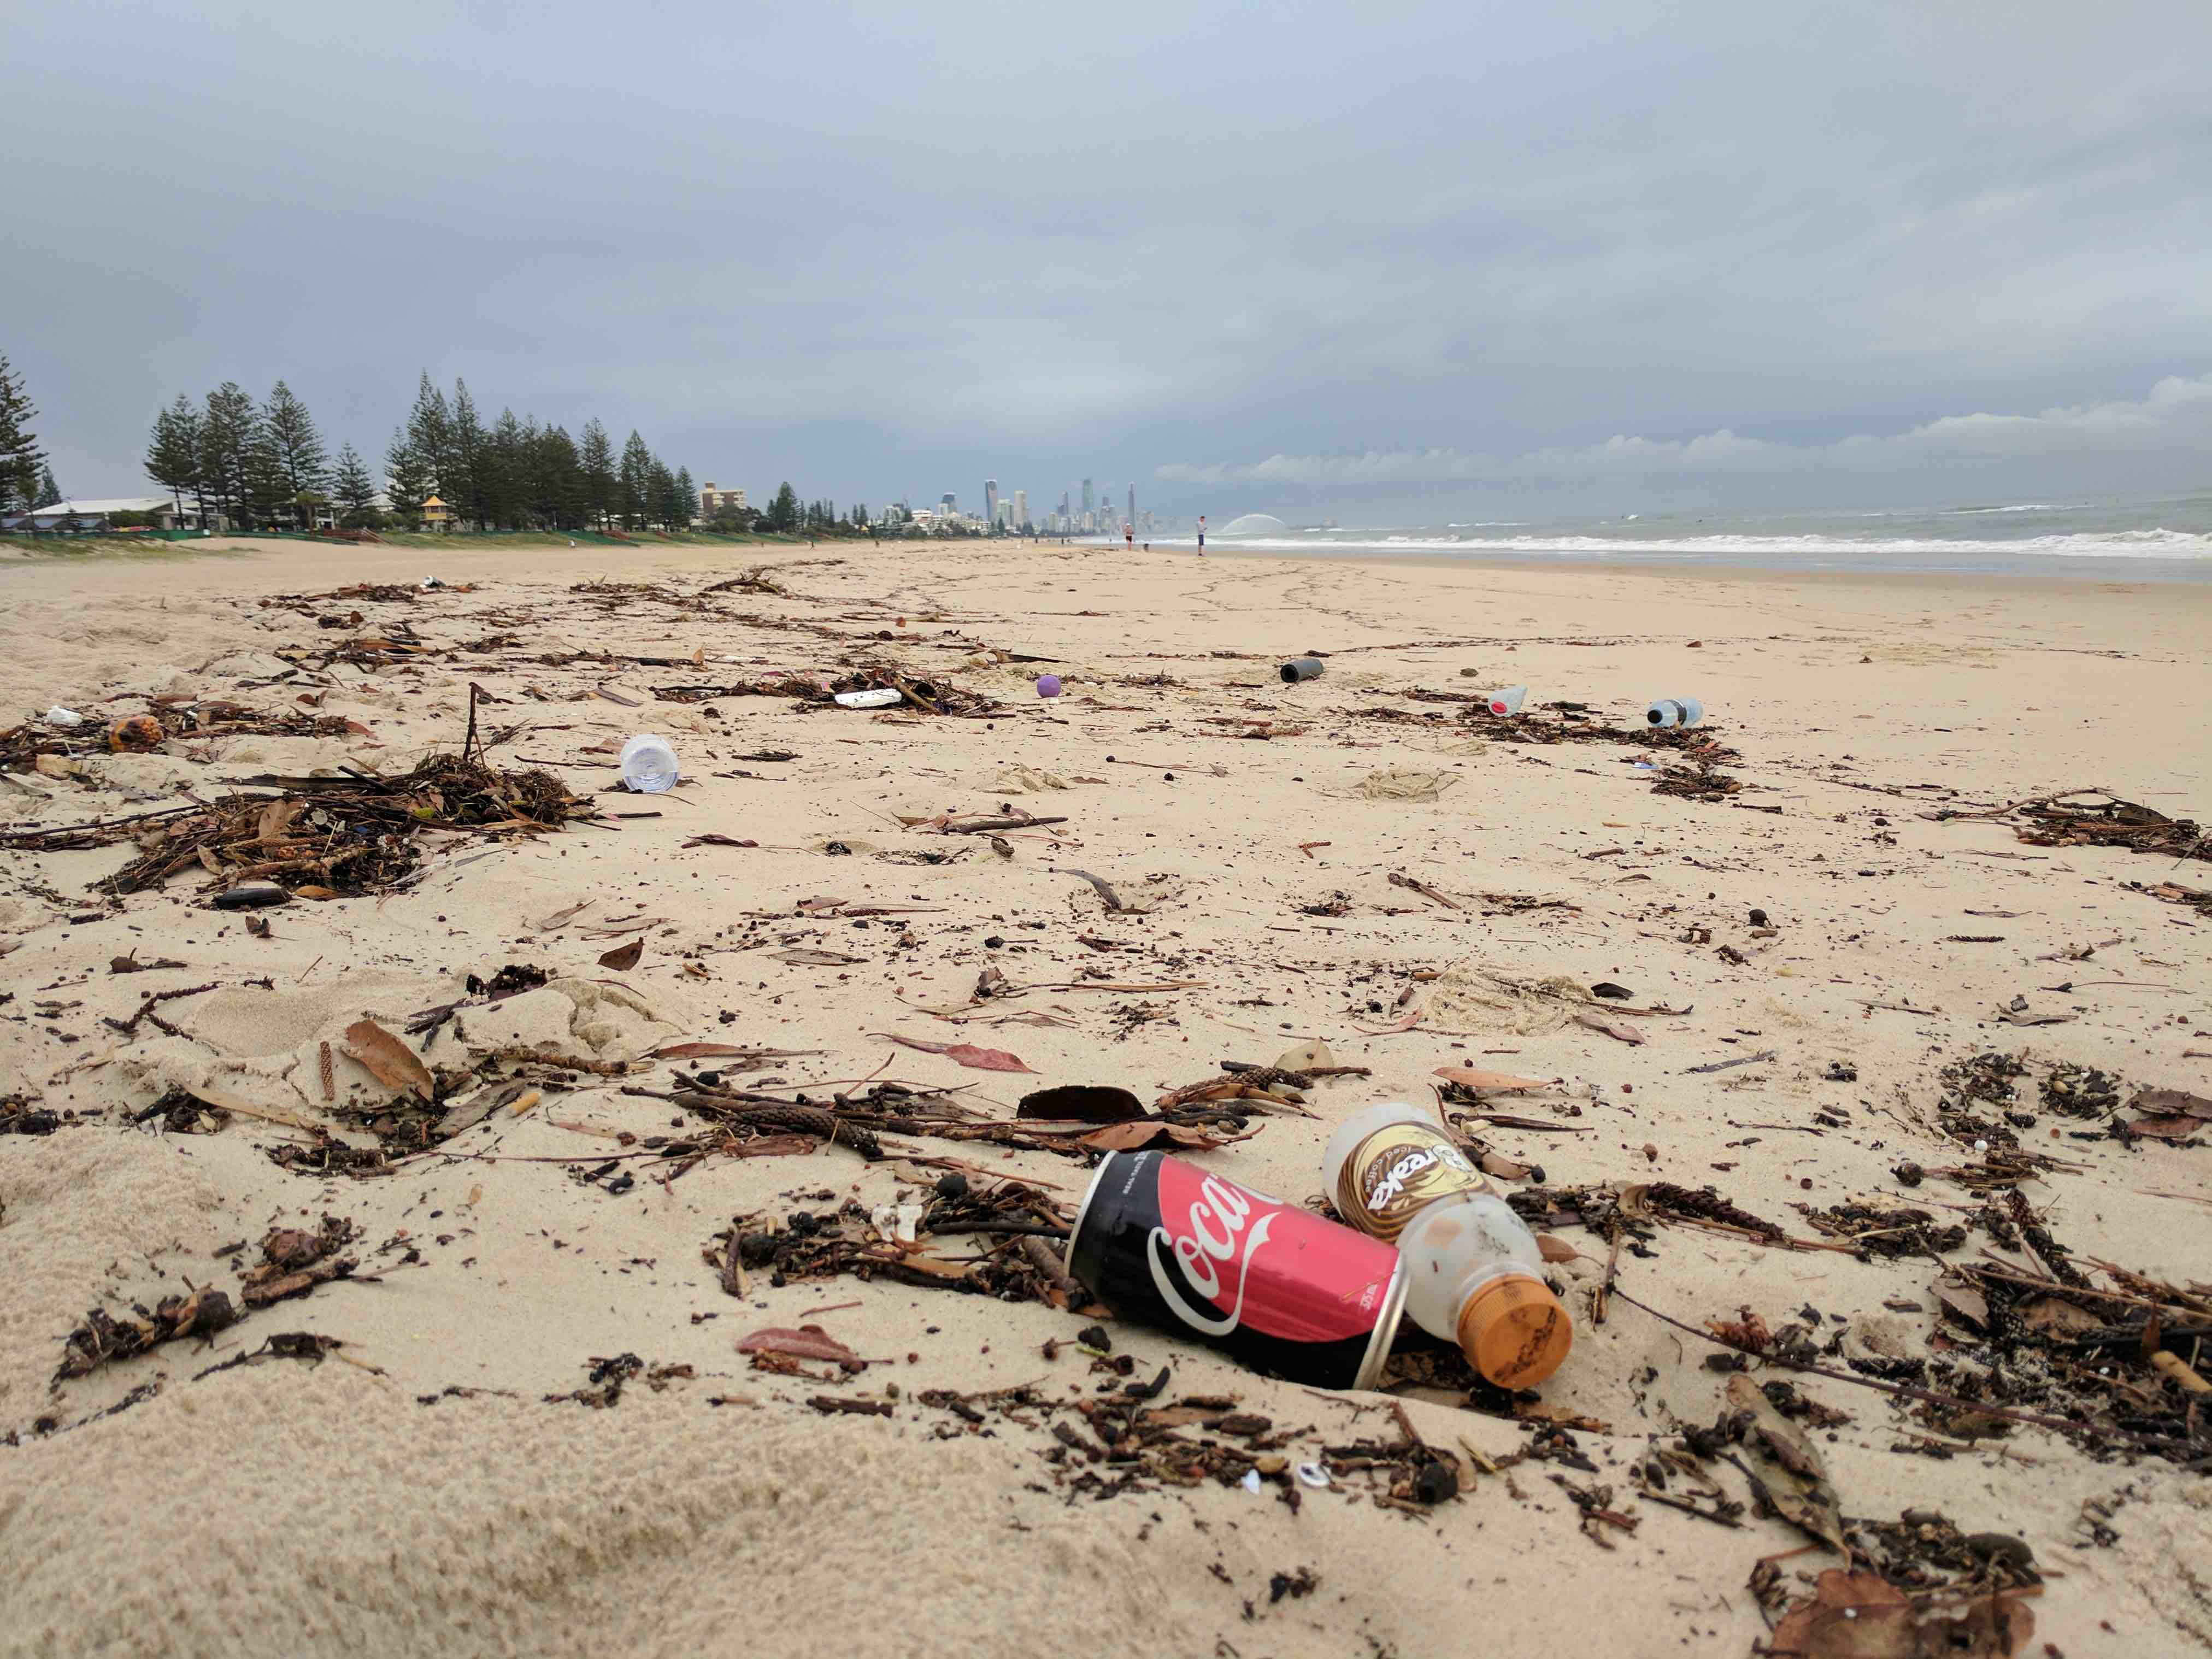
[74,754,591,898]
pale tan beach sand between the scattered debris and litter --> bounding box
[0,542,2212,1655]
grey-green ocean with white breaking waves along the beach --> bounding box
[1152,493,2212,582]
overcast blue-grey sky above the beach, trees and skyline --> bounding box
[0,0,2212,522]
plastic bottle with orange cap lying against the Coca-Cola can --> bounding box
[1321,1099,1575,1389]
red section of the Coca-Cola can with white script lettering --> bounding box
[1144,1159,1398,1343]
